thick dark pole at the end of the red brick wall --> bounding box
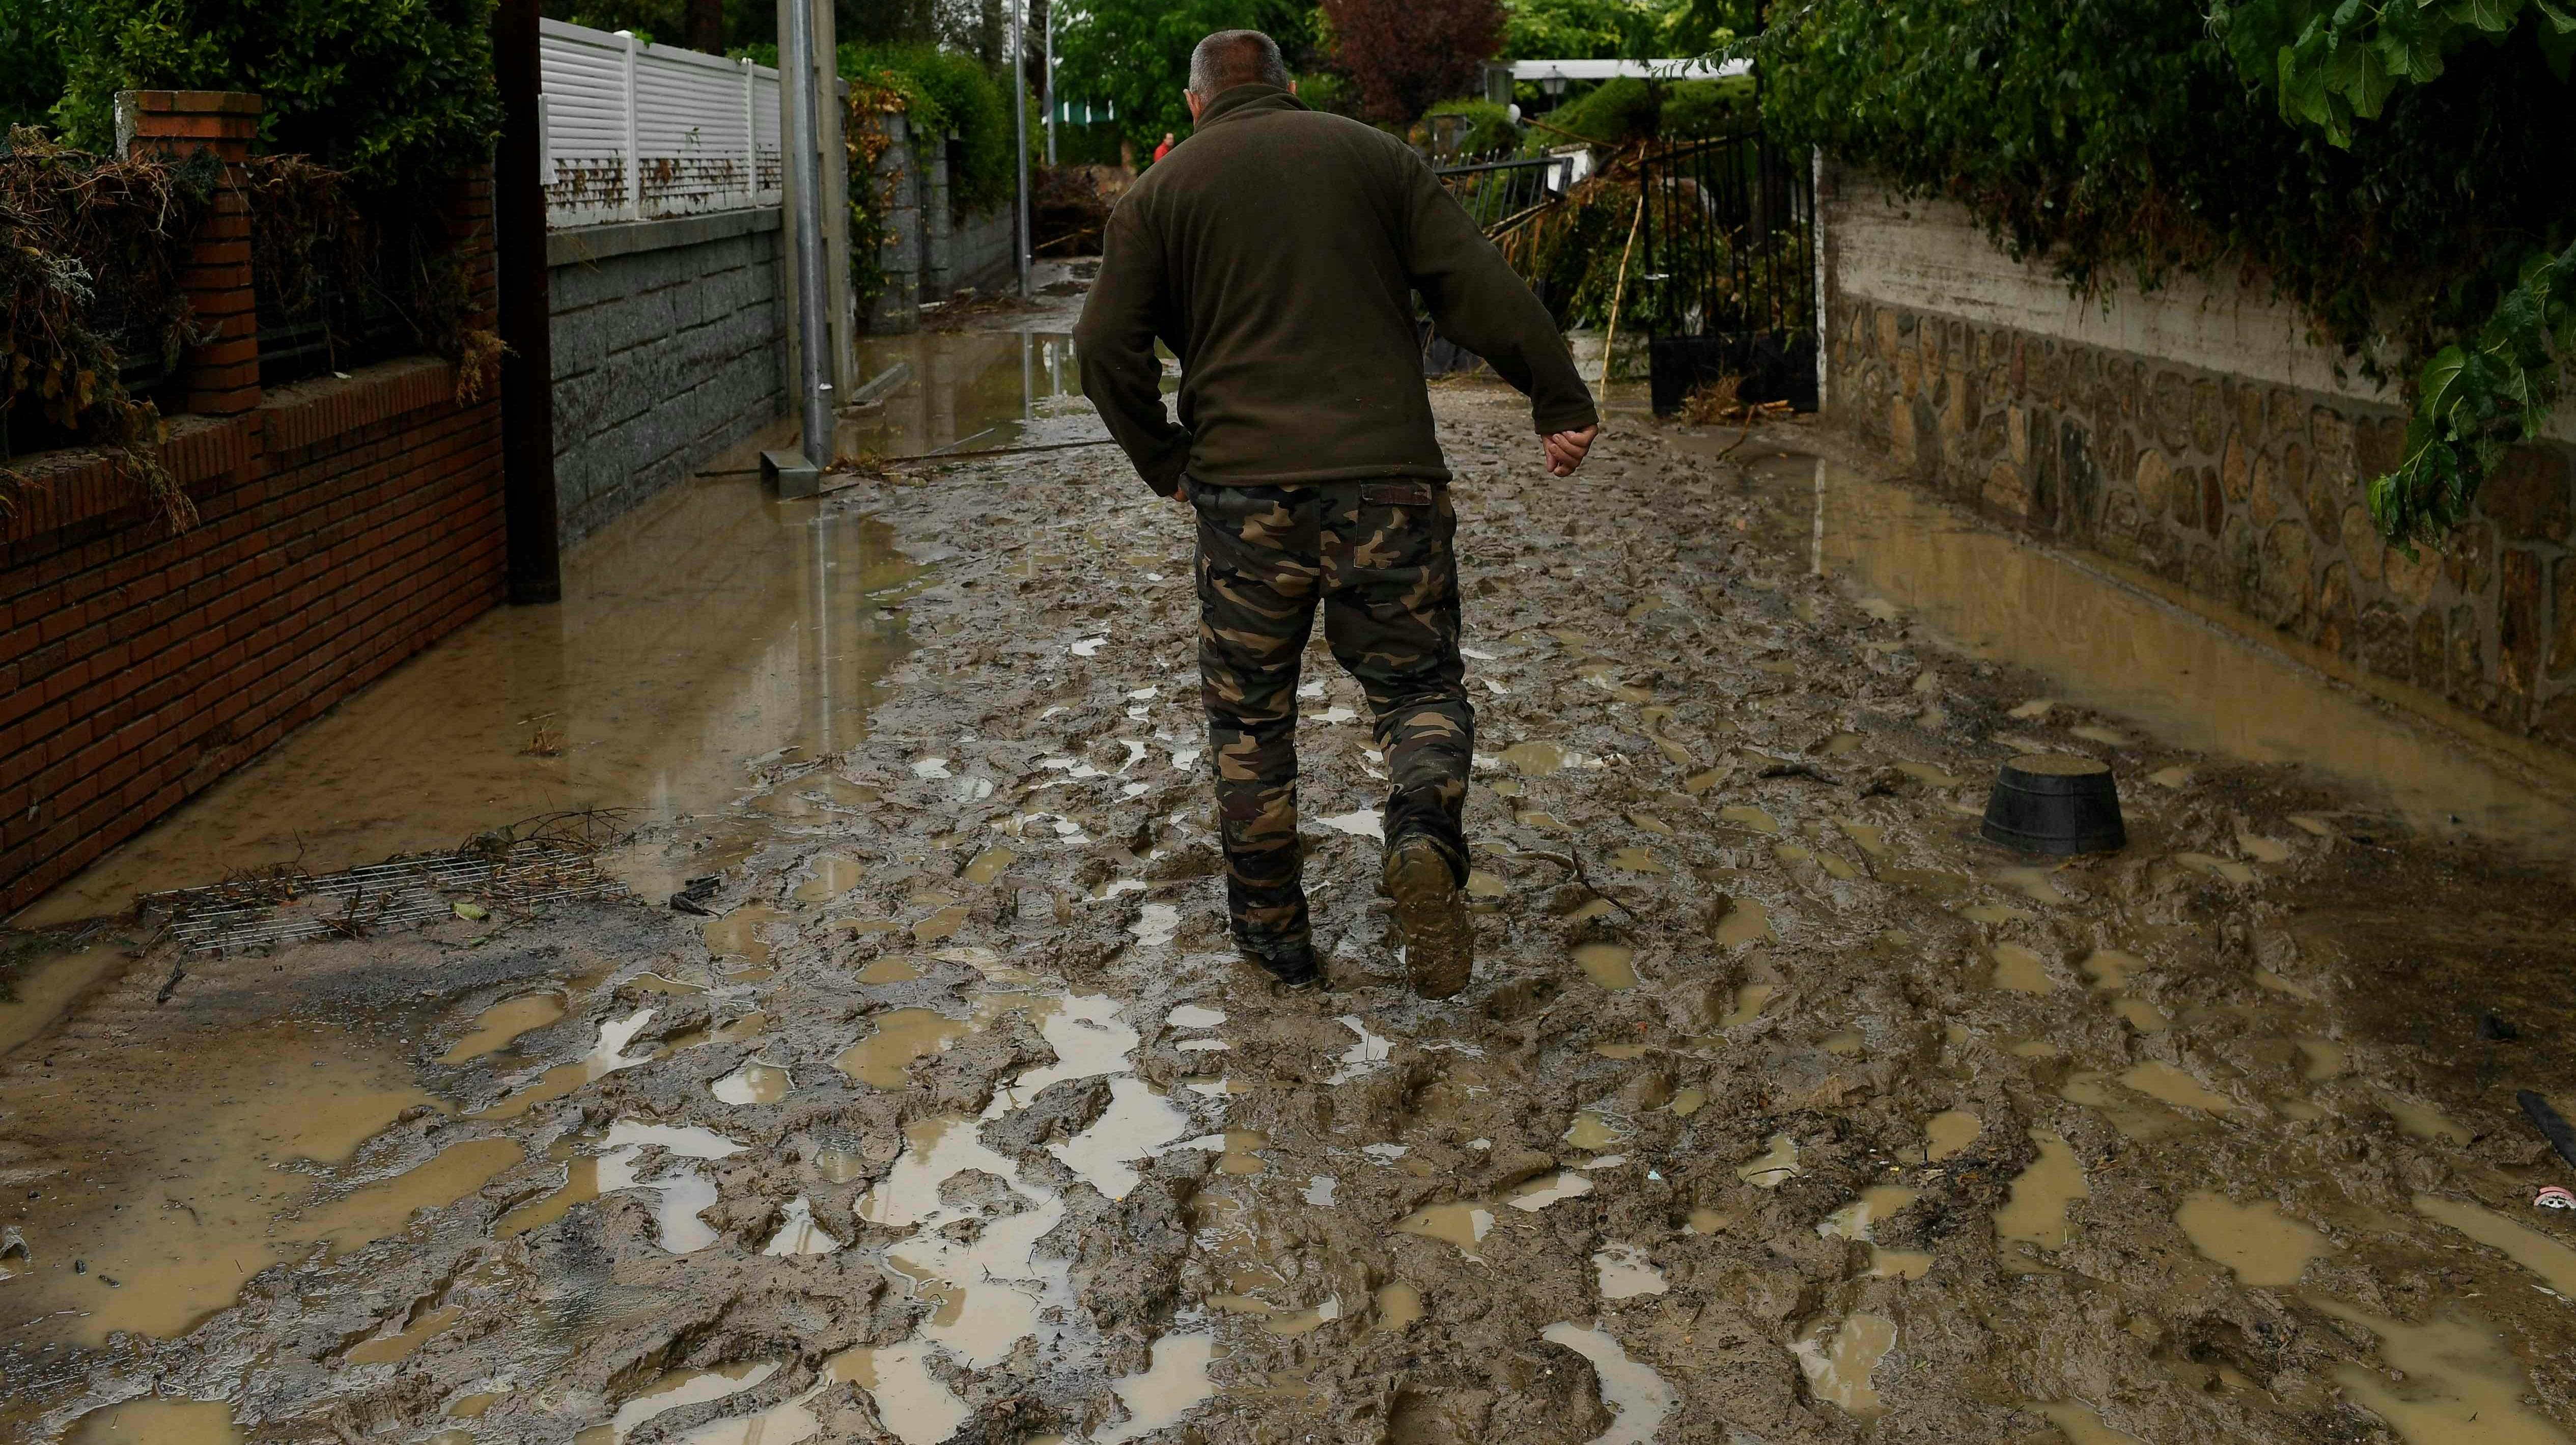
[492,0,564,603]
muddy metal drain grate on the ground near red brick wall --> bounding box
[139,840,626,953]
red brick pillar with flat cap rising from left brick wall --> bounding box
[116,90,260,418]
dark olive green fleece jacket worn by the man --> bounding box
[1074,85,1597,497]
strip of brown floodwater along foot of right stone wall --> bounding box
[1721,443,2576,858]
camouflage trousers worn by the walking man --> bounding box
[1193,479,1476,946]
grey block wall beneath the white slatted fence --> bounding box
[546,211,788,541]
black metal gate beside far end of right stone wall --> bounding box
[1633,134,1816,414]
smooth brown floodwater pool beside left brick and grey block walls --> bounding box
[15,477,917,927]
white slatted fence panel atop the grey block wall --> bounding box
[539,20,780,227]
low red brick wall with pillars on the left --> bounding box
[0,90,502,912]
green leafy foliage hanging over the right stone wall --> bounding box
[1749,0,2576,538]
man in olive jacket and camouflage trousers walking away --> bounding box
[1074,31,1597,999]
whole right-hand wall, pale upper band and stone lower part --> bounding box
[1824,175,2576,752]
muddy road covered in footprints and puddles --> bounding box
[0,340,2576,1445]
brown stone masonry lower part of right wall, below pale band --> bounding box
[1827,286,2576,752]
